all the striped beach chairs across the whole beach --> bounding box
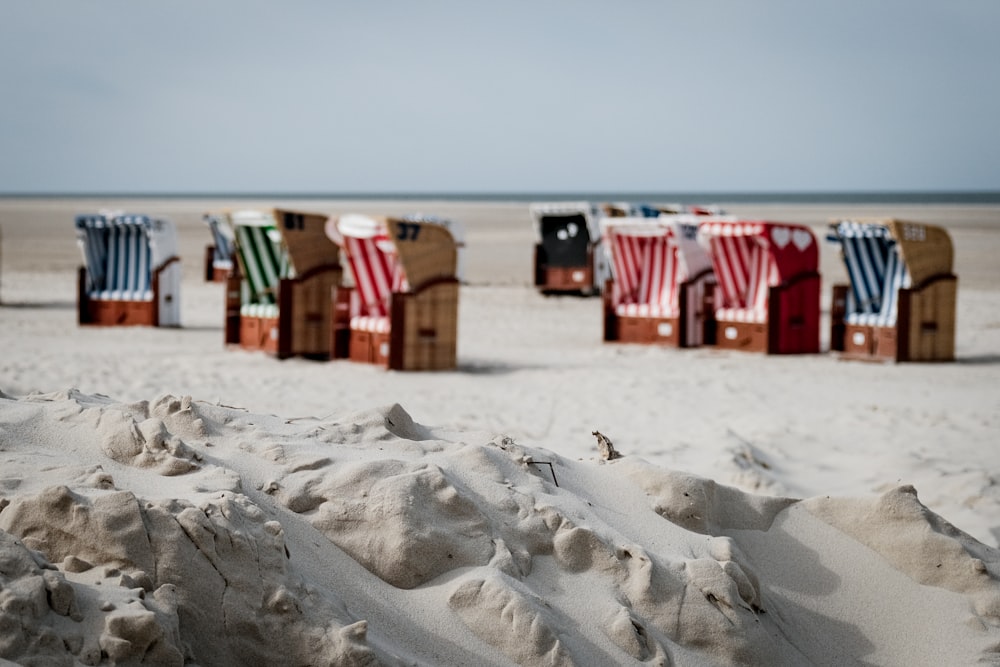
[76,202,957,370]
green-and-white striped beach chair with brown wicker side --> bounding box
[225,209,342,359]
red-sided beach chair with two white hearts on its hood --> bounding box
[698,218,820,354]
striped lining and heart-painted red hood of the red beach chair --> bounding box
[698,219,819,321]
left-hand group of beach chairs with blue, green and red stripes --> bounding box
[76,209,462,370]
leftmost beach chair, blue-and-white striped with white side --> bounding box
[75,213,181,326]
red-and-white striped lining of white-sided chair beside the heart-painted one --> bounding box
[606,223,680,317]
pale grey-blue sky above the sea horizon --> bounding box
[0,0,1000,194]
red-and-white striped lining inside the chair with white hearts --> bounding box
[699,222,781,322]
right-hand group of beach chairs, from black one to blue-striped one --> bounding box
[531,202,957,361]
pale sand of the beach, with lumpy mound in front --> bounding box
[0,200,1000,665]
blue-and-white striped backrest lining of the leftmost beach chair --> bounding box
[76,215,153,301]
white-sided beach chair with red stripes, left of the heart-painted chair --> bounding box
[600,215,715,347]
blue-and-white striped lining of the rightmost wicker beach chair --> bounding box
[835,221,910,326]
